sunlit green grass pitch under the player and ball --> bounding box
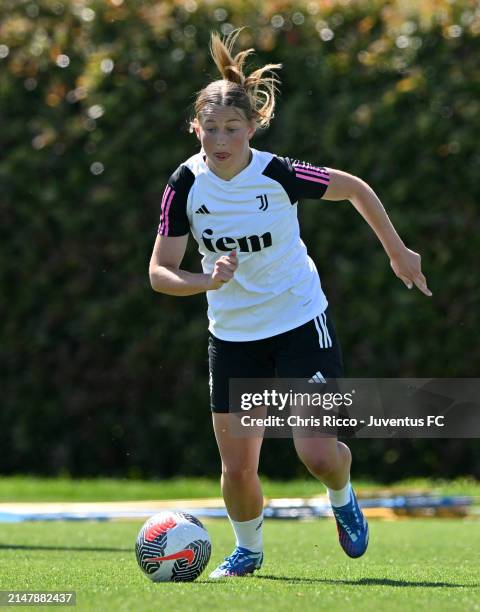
[0,519,480,612]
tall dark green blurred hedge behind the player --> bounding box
[0,0,480,480]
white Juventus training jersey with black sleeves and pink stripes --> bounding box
[158,149,329,341]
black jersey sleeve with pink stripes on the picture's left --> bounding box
[158,164,195,236]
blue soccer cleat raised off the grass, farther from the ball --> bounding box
[332,489,368,559]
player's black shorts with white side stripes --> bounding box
[208,308,343,412]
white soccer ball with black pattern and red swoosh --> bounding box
[135,510,212,582]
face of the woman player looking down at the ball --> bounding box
[194,105,255,180]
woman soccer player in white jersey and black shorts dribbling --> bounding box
[149,30,431,578]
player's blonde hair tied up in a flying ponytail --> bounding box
[190,28,282,132]
